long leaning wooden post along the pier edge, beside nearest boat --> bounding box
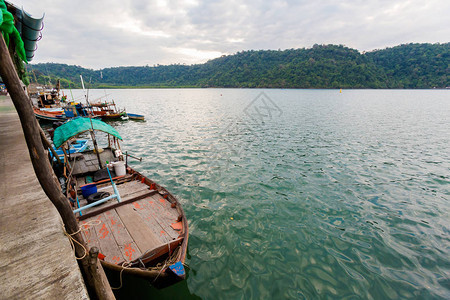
[0,34,115,299]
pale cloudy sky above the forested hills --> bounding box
[10,0,450,69]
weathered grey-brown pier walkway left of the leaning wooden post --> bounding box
[0,96,89,299]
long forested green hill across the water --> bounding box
[27,43,450,88]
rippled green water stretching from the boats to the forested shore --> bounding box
[65,89,450,299]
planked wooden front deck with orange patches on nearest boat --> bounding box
[80,180,182,264]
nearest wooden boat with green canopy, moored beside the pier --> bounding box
[53,118,189,287]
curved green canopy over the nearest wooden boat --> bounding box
[53,117,122,148]
